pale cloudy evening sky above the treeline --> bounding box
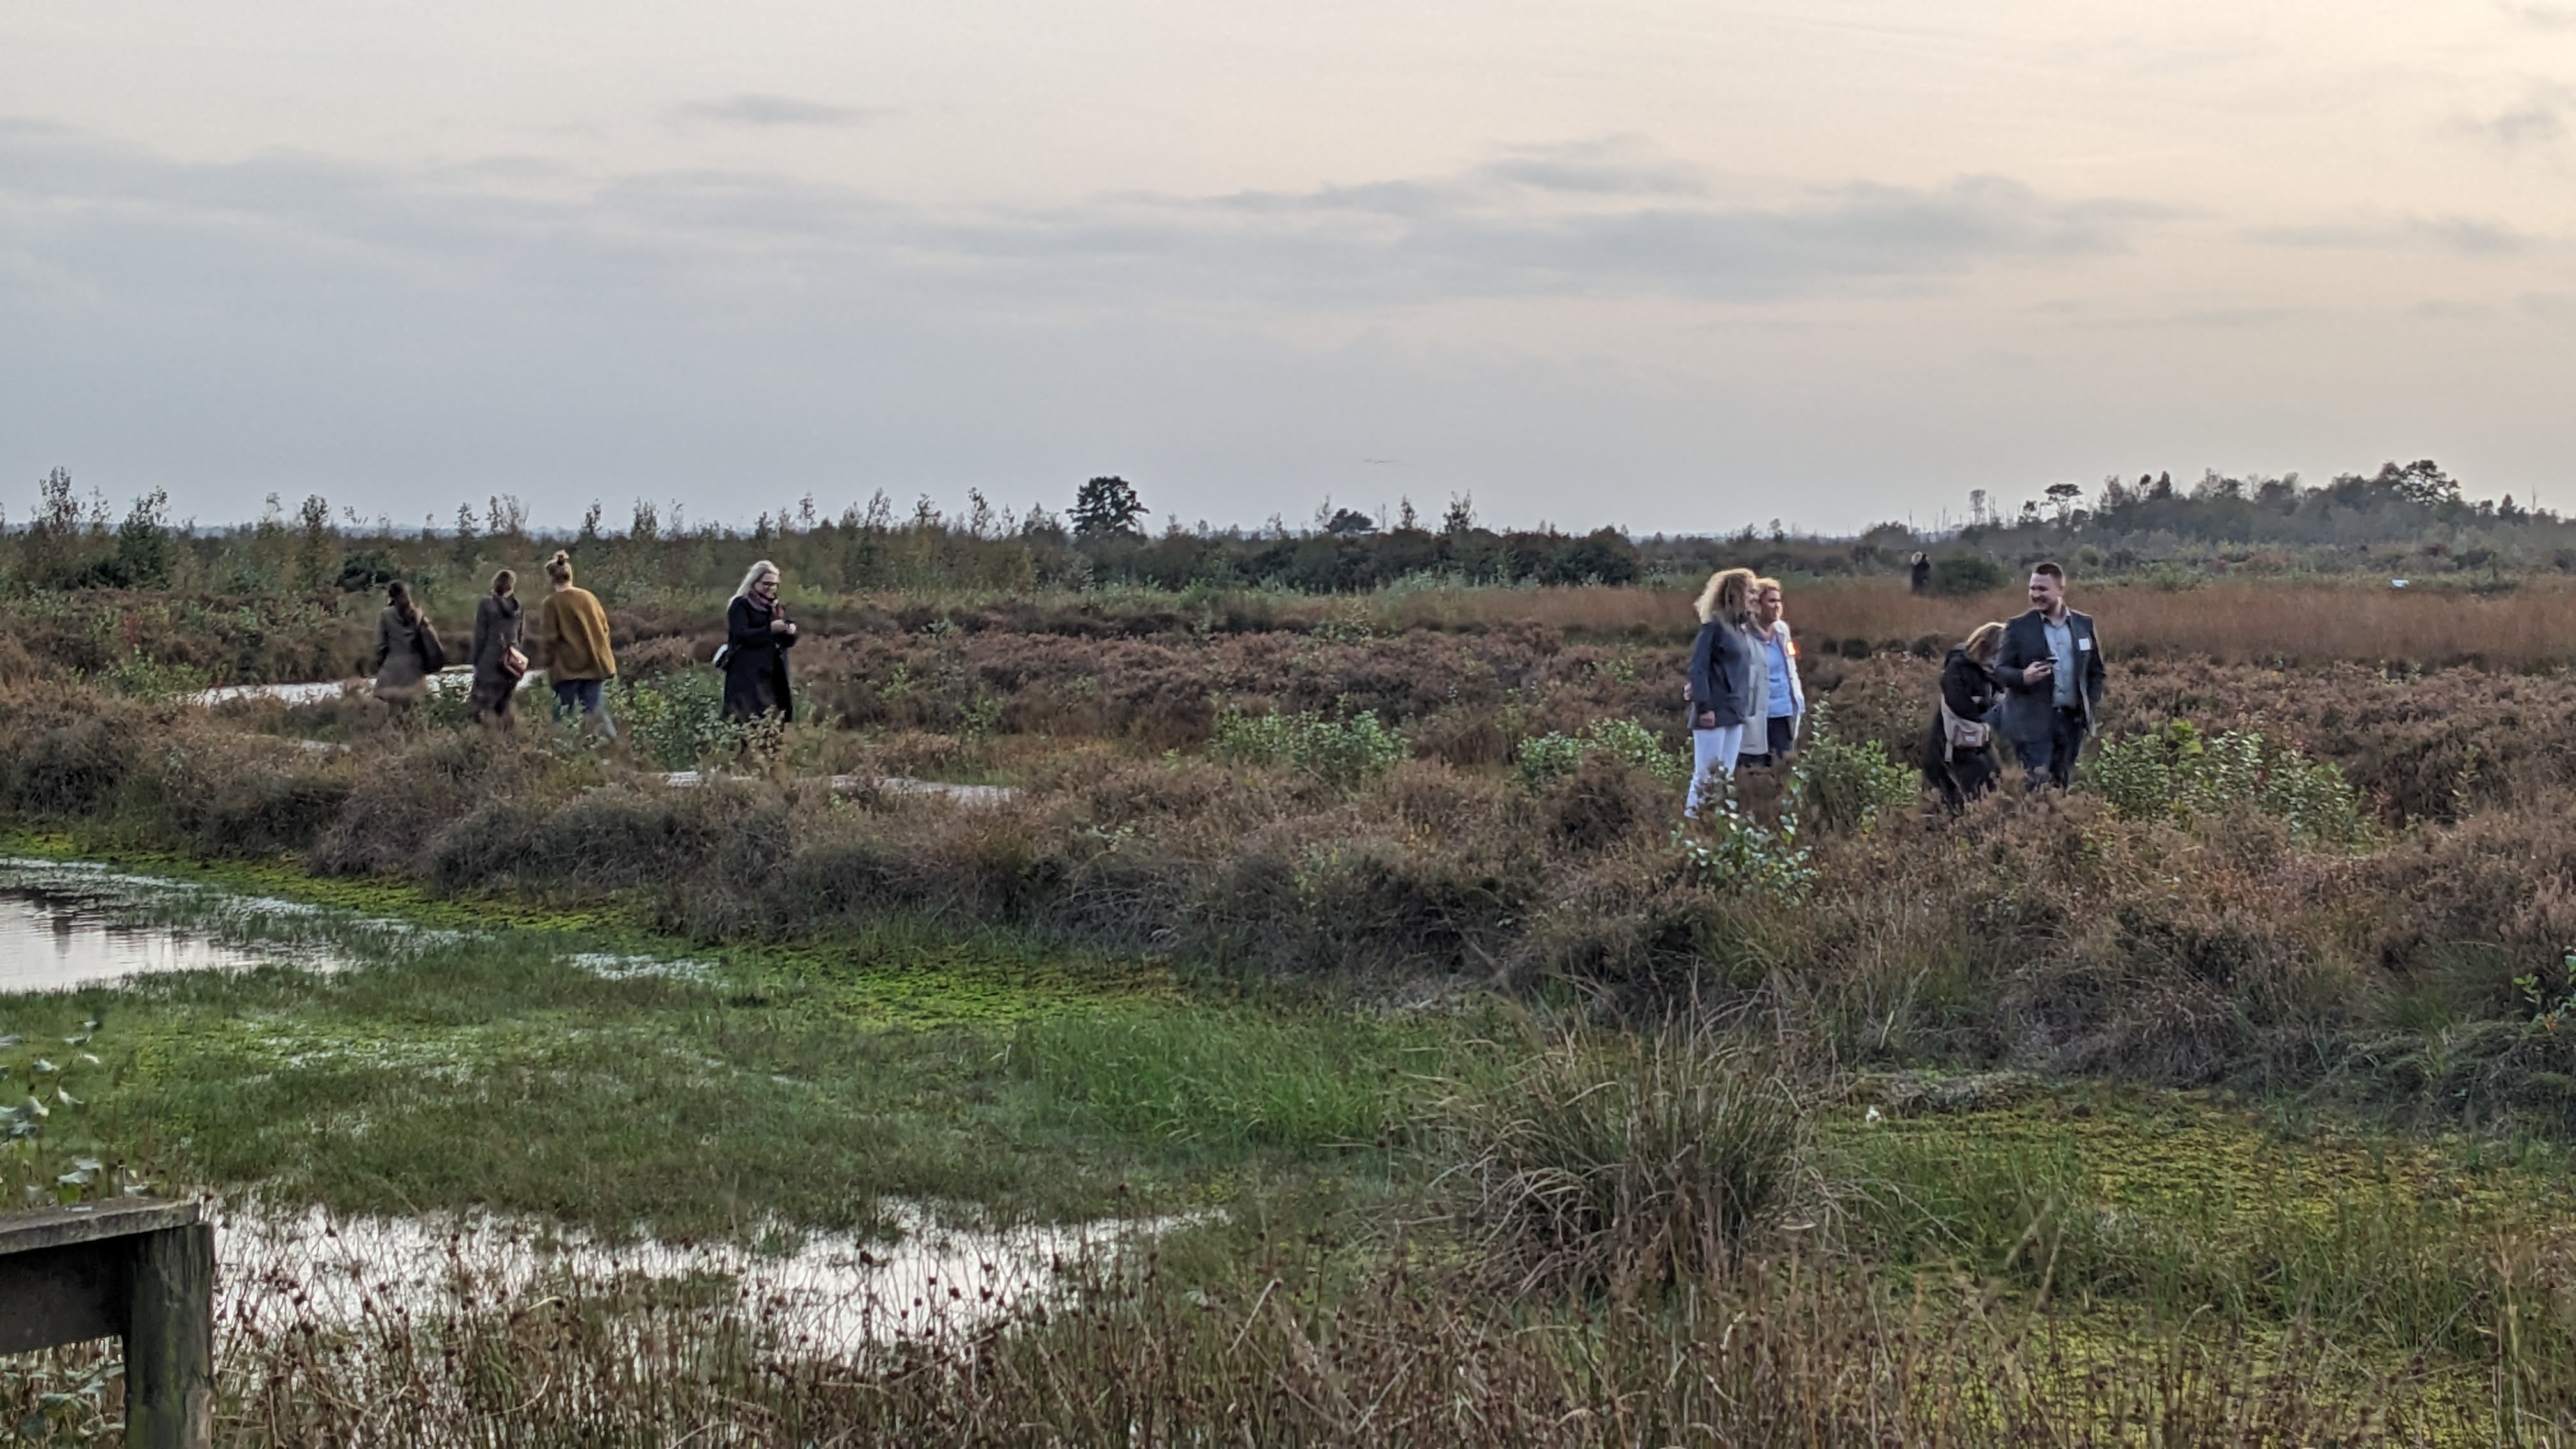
[0,0,2576,533]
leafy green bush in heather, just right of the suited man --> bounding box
[2084,719,2367,846]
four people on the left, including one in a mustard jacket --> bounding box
[371,549,796,740]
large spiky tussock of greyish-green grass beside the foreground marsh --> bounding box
[1443,1026,1808,1287]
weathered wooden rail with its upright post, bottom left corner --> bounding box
[0,1199,214,1449]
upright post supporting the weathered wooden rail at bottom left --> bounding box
[126,1222,214,1449]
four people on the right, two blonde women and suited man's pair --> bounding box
[1682,562,2104,817]
